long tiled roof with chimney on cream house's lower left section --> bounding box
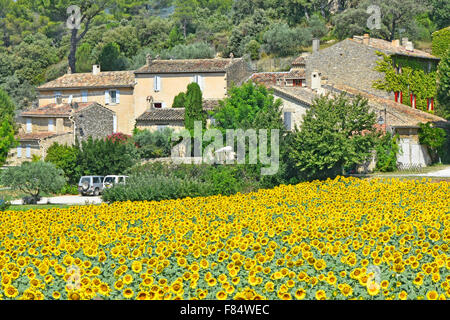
[38,71,135,90]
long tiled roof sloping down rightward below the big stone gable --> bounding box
[324,84,450,127]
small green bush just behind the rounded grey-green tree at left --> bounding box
[45,142,81,184]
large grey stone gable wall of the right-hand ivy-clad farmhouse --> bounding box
[306,39,392,99]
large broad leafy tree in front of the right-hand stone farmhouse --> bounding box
[288,94,377,180]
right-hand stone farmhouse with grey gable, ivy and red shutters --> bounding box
[251,35,450,170]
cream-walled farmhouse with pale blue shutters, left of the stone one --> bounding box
[6,56,251,165]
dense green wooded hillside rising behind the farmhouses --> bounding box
[0,0,442,112]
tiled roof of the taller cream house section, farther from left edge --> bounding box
[135,58,242,73]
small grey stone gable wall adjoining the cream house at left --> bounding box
[73,104,114,141]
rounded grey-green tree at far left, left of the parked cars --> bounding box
[0,161,66,202]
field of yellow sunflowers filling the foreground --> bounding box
[0,177,450,299]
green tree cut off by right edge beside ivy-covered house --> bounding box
[436,48,450,120]
